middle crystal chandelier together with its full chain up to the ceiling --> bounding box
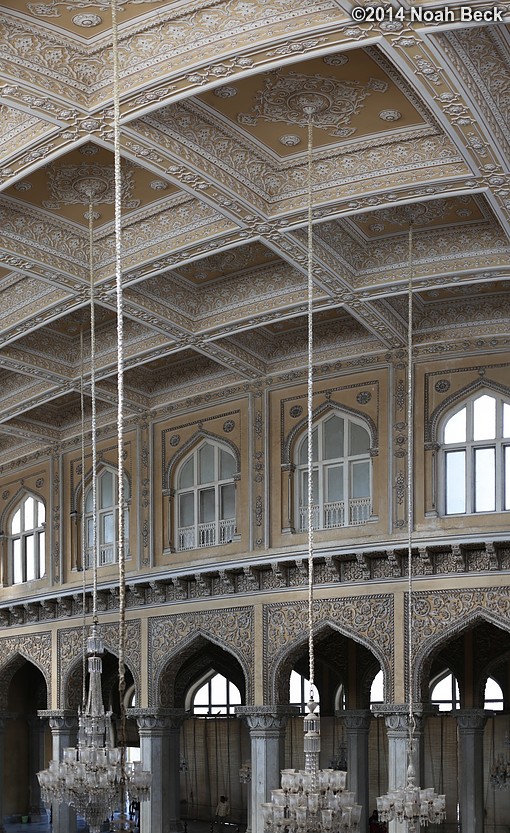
[262,104,362,833]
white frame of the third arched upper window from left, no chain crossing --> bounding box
[173,438,237,552]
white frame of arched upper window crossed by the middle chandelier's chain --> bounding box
[294,409,374,532]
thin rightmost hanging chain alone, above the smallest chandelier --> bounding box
[407,222,415,750]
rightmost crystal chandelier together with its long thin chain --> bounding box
[377,220,446,831]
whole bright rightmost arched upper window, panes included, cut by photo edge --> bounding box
[441,393,510,515]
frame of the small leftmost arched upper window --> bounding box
[8,492,46,585]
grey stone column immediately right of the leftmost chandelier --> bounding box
[128,709,186,833]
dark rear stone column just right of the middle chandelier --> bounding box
[337,709,372,830]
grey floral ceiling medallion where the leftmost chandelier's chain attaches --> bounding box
[43,164,138,209]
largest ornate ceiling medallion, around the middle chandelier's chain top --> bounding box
[237,71,388,137]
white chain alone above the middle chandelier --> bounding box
[307,113,315,700]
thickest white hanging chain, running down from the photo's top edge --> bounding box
[112,0,126,792]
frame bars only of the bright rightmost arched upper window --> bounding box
[438,389,510,518]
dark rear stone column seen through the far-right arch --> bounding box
[455,709,488,833]
